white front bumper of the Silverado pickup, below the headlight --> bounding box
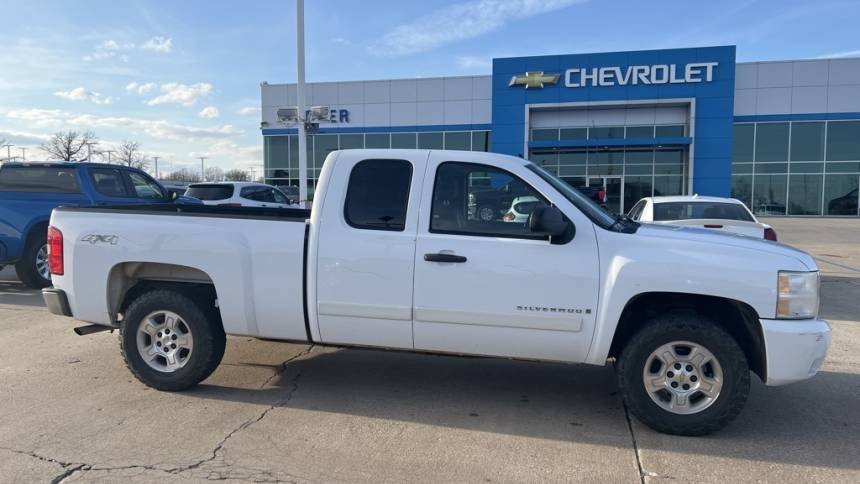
[760,319,830,386]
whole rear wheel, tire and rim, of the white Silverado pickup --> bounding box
[120,289,226,391]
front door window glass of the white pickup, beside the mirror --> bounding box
[430,162,549,239]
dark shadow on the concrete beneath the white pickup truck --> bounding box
[193,349,860,469]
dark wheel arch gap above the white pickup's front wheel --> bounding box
[608,292,767,381]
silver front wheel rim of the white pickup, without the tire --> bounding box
[642,341,723,415]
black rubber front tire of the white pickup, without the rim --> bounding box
[616,314,750,436]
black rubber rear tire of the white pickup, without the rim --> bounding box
[119,289,227,391]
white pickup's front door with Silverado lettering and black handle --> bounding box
[413,153,599,361]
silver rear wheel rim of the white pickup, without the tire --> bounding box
[137,311,194,373]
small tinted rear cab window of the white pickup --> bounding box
[343,160,412,232]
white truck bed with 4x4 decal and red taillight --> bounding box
[51,205,310,340]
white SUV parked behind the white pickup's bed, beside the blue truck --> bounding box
[185,182,295,208]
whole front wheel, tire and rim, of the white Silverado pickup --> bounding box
[617,315,750,435]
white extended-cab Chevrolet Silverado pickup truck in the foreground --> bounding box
[44,150,830,435]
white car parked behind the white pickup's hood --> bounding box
[627,195,777,241]
